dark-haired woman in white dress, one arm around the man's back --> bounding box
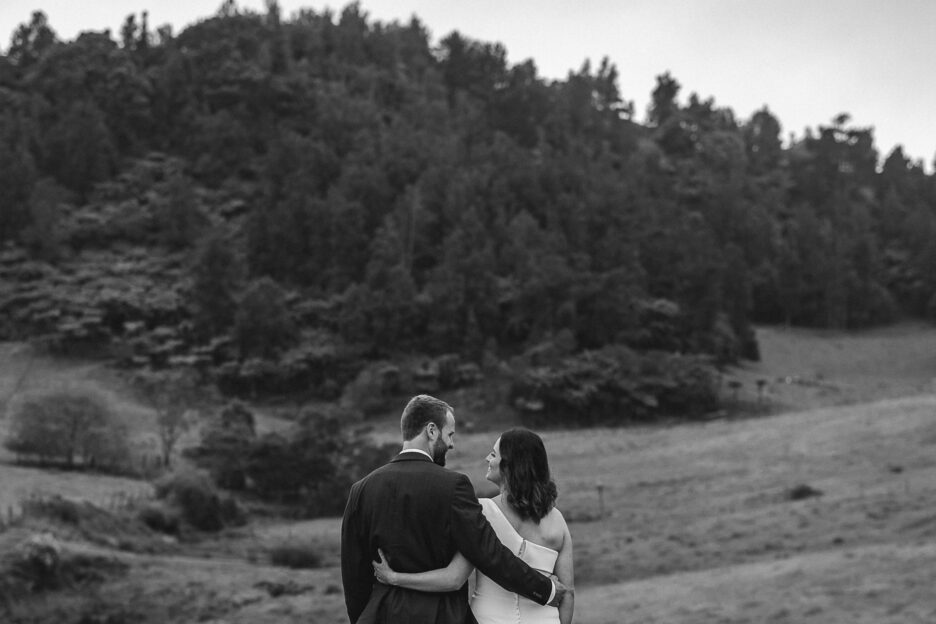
[374,429,574,624]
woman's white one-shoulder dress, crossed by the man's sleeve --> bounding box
[471,498,559,624]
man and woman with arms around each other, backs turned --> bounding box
[341,395,573,624]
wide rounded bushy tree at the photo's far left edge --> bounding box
[5,387,129,469]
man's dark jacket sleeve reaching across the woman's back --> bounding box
[451,475,553,604]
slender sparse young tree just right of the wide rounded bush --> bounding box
[134,370,202,468]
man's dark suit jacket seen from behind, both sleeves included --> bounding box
[341,453,552,624]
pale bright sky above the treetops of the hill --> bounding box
[0,0,936,171]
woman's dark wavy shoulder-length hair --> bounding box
[500,428,558,523]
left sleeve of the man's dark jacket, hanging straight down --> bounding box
[341,483,374,624]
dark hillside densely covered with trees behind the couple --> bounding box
[0,0,936,420]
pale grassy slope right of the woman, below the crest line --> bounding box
[568,397,936,623]
